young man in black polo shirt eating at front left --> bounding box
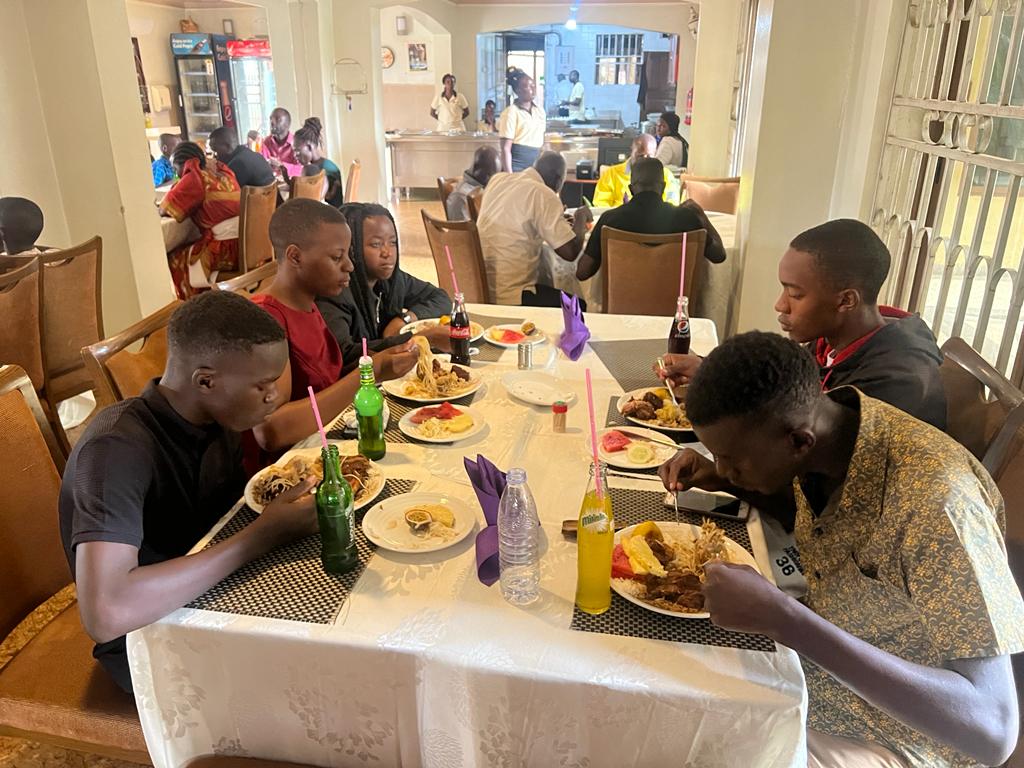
[60,291,316,691]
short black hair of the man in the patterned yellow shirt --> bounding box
[686,331,821,427]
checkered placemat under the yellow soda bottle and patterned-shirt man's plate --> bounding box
[569,488,775,651]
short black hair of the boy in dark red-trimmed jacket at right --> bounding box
[790,219,892,304]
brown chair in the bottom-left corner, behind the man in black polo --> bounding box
[0,366,150,763]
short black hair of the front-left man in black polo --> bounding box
[167,291,286,356]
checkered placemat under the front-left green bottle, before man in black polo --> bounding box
[186,479,416,624]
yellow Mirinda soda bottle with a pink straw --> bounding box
[575,463,615,615]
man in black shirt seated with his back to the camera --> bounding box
[577,158,725,280]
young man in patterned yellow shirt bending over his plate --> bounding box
[662,332,1024,768]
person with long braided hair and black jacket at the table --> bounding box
[316,203,452,370]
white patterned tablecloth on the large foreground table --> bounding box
[128,306,807,768]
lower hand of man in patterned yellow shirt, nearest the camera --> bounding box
[700,562,795,642]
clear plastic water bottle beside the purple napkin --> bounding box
[498,469,541,605]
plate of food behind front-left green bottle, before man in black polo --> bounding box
[245,449,384,513]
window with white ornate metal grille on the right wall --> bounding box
[870,0,1024,386]
